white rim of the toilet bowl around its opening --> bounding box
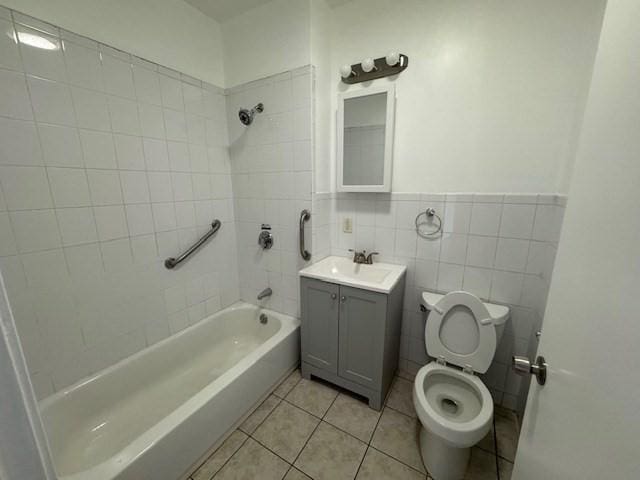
[413,362,493,448]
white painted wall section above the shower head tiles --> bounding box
[222,0,311,87]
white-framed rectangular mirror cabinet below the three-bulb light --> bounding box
[337,85,395,192]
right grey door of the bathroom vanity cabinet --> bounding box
[338,287,387,389]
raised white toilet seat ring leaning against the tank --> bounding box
[425,292,496,373]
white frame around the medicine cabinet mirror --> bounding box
[336,83,396,192]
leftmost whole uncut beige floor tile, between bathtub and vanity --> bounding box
[253,402,319,462]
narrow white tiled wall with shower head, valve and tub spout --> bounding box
[227,67,313,315]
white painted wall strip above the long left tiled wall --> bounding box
[1,0,224,86]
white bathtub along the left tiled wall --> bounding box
[40,303,300,480]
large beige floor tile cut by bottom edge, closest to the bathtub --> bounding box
[214,438,289,480]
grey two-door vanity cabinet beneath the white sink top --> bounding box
[300,276,404,410]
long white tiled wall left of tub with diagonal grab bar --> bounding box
[0,9,239,397]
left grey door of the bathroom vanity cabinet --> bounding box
[300,278,338,374]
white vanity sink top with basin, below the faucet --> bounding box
[300,257,407,293]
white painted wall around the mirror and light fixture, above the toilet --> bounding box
[316,0,604,193]
